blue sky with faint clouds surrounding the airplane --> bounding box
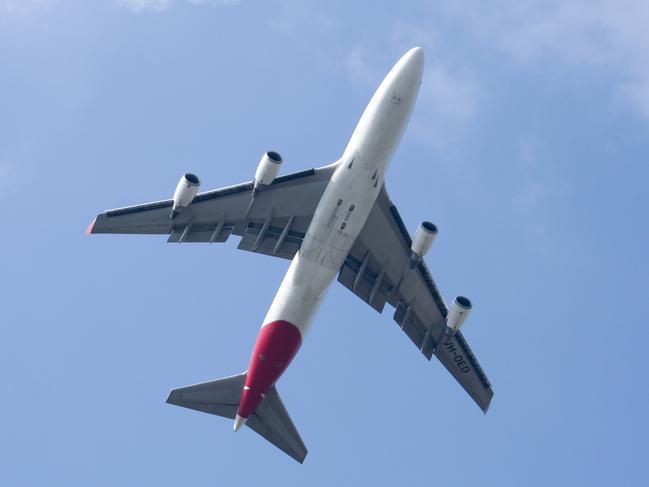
[0,0,649,486]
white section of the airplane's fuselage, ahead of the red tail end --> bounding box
[264,48,423,338]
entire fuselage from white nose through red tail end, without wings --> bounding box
[234,48,423,430]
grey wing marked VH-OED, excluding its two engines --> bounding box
[338,186,493,412]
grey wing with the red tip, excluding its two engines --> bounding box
[88,166,334,259]
